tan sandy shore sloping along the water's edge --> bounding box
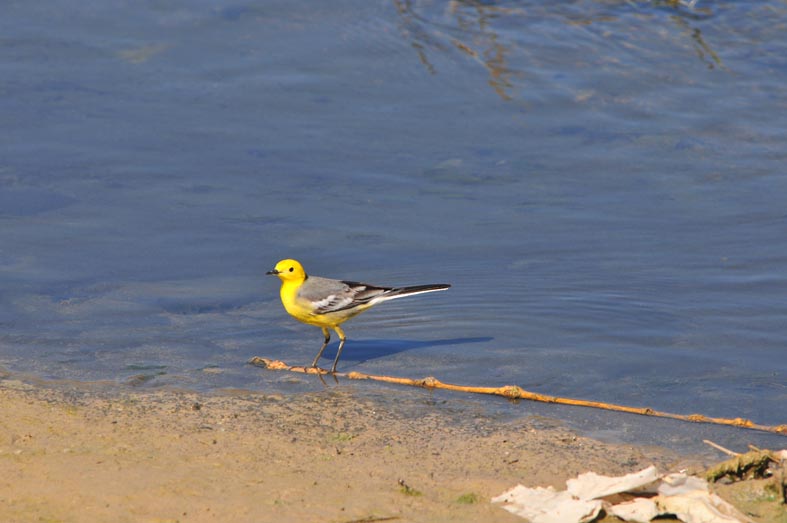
[0,376,700,523]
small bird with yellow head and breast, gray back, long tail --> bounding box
[266,259,450,373]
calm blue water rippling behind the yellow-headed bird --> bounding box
[0,0,787,446]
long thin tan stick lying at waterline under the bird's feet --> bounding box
[249,356,787,435]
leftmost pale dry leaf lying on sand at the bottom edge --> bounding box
[492,485,602,523]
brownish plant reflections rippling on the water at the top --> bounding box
[393,0,723,101]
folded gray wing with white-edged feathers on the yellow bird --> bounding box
[298,276,391,314]
